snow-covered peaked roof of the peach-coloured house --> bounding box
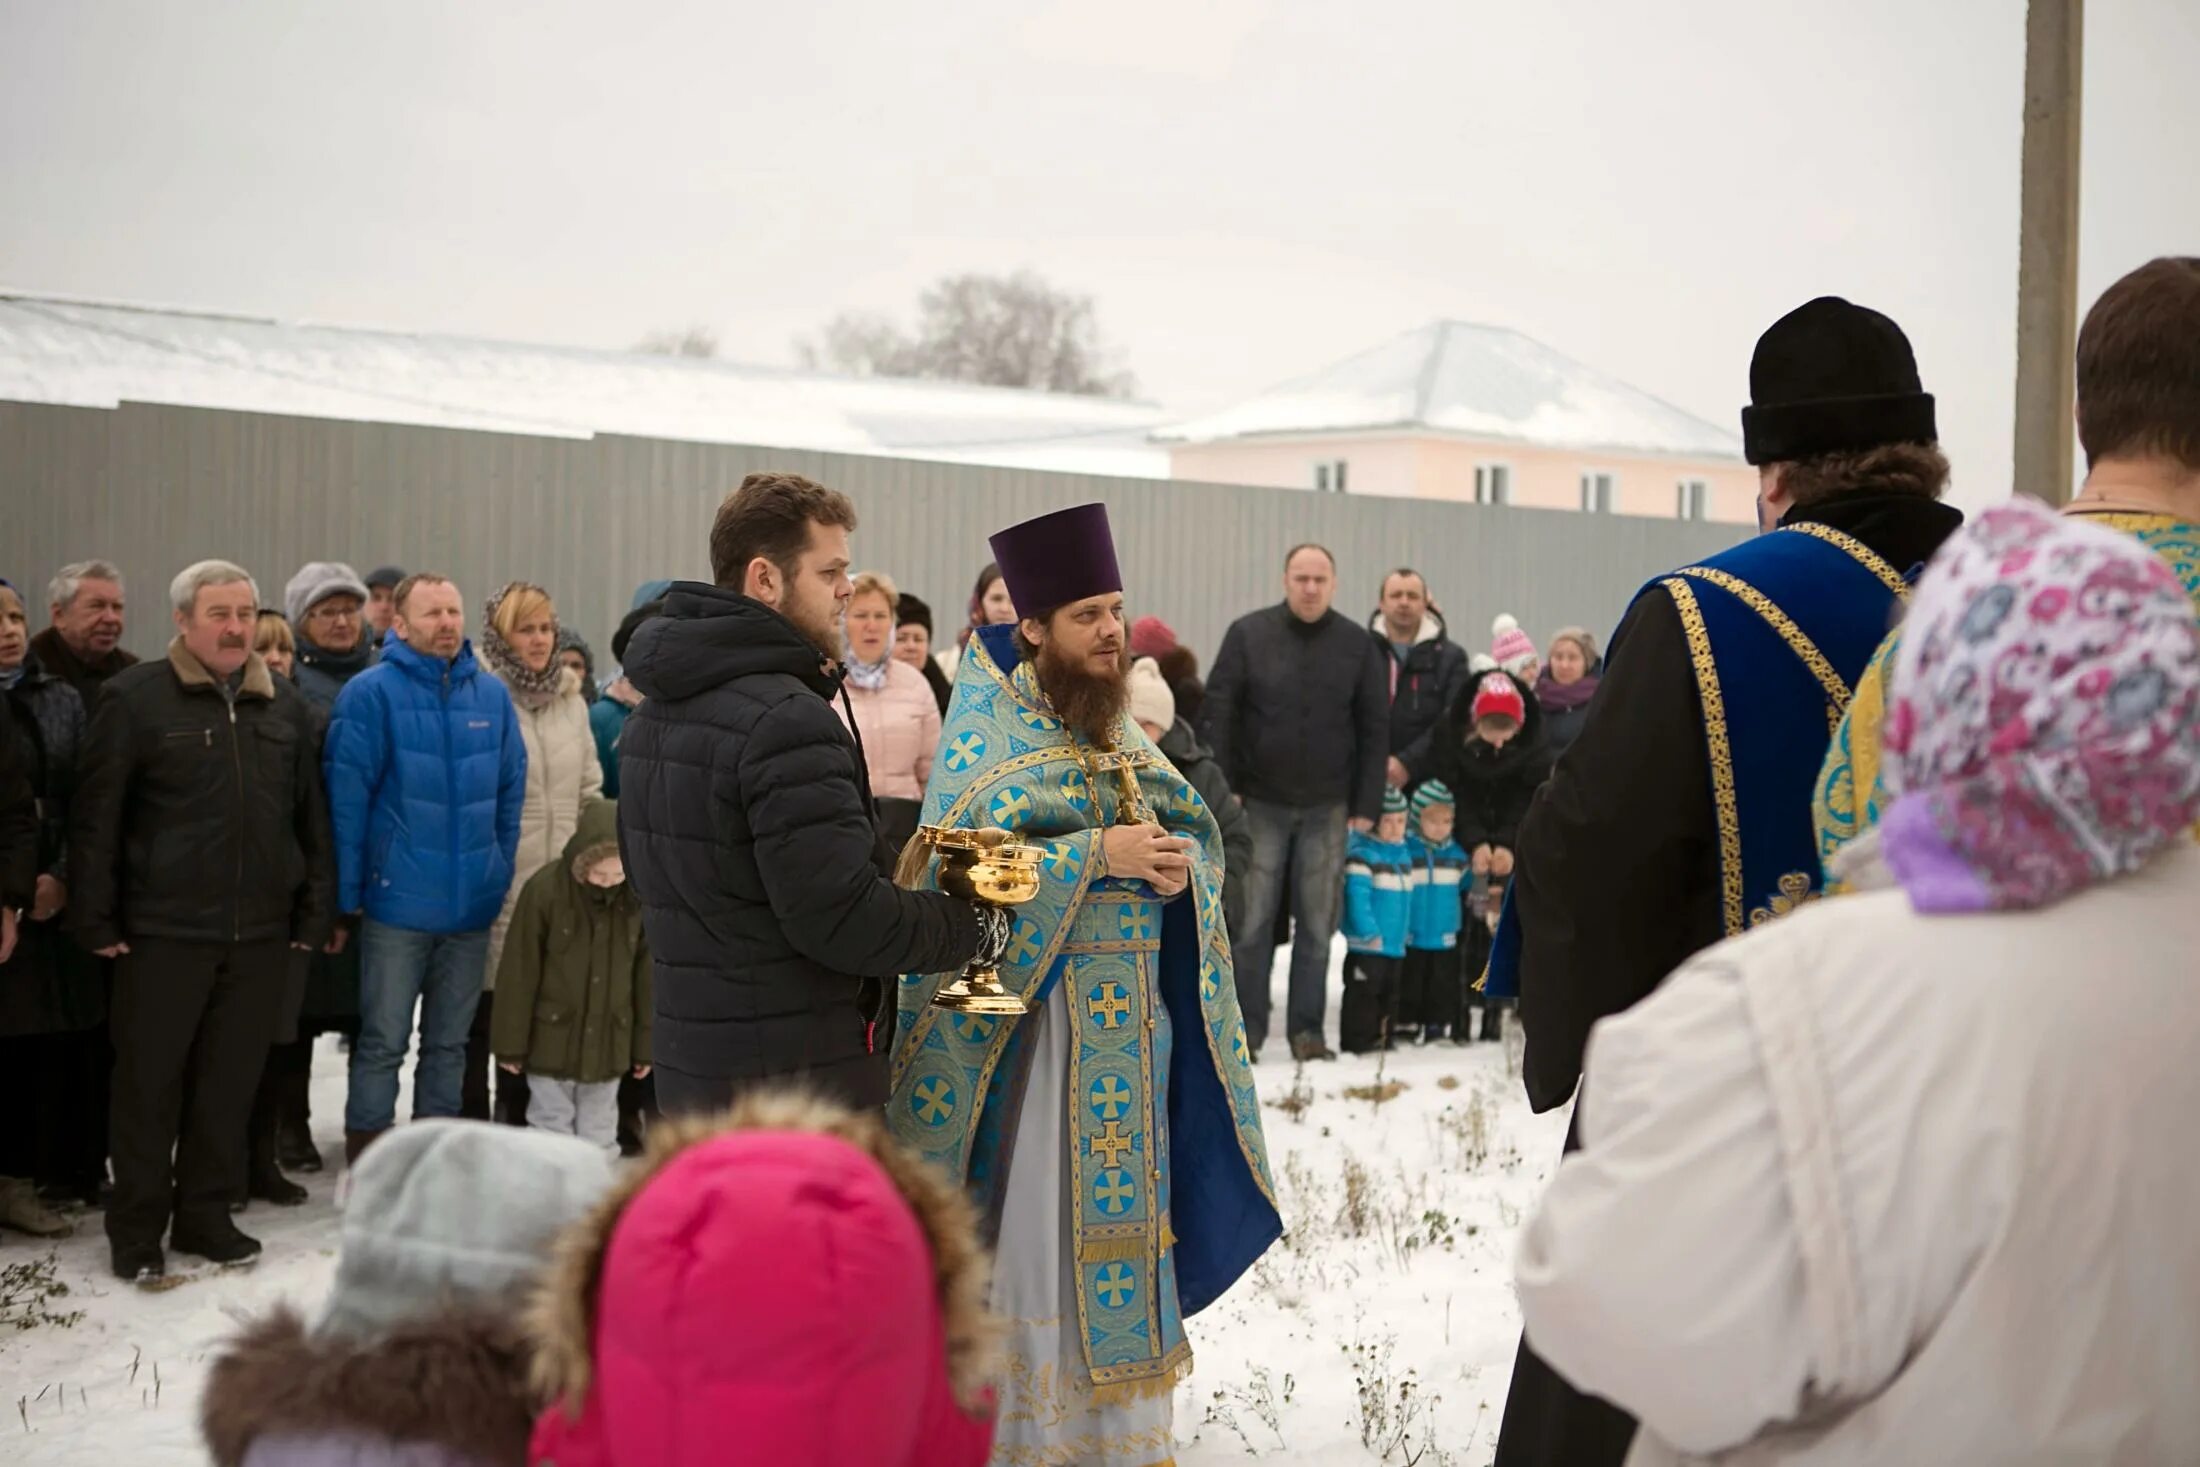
[1155,321,1742,460]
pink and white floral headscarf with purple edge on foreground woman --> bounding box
[1881,499,2200,913]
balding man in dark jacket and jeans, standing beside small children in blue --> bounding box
[1206,545,1390,1060]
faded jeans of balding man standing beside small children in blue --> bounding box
[1232,801,1344,1049]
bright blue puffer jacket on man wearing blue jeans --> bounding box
[323,638,528,933]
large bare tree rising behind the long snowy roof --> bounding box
[794,271,1137,398]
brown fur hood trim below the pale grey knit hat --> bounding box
[198,1309,537,1467]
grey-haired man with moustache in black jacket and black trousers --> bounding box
[68,561,334,1282]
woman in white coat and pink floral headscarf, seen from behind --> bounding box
[1518,501,2200,1467]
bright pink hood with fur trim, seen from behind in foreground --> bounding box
[528,1093,997,1467]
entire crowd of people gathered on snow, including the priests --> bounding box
[0,260,2200,1467]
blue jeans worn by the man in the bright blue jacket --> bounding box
[343,917,488,1130]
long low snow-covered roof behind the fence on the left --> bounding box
[0,290,1168,477]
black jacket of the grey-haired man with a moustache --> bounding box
[66,638,337,950]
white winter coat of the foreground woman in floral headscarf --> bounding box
[1518,845,2200,1467]
